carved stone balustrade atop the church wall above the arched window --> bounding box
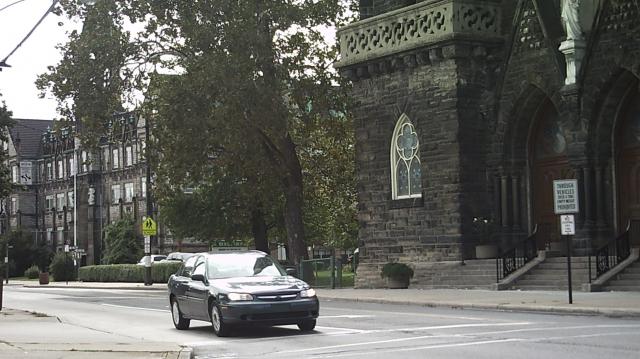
[335,0,501,68]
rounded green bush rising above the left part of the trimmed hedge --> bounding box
[102,217,142,264]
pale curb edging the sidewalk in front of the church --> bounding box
[319,296,640,318]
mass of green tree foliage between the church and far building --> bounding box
[38,0,356,263]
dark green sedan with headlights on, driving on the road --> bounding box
[169,251,319,337]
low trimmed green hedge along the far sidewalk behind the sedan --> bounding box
[78,262,182,283]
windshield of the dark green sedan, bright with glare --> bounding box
[207,253,287,279]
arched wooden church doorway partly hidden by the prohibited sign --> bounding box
[529,99,575,249]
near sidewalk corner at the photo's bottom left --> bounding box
[0,307,191,359]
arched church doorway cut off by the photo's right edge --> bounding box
[615,86,640,245]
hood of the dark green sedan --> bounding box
[209,276,309,294]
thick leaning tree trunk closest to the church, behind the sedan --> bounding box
[281,134,309,264]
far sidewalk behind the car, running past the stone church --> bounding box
[9,281,640,317]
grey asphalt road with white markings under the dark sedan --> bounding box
[5,287,640,359]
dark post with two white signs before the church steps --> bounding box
[553,179,580,304]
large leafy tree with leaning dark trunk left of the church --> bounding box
[39,0,352,262]
